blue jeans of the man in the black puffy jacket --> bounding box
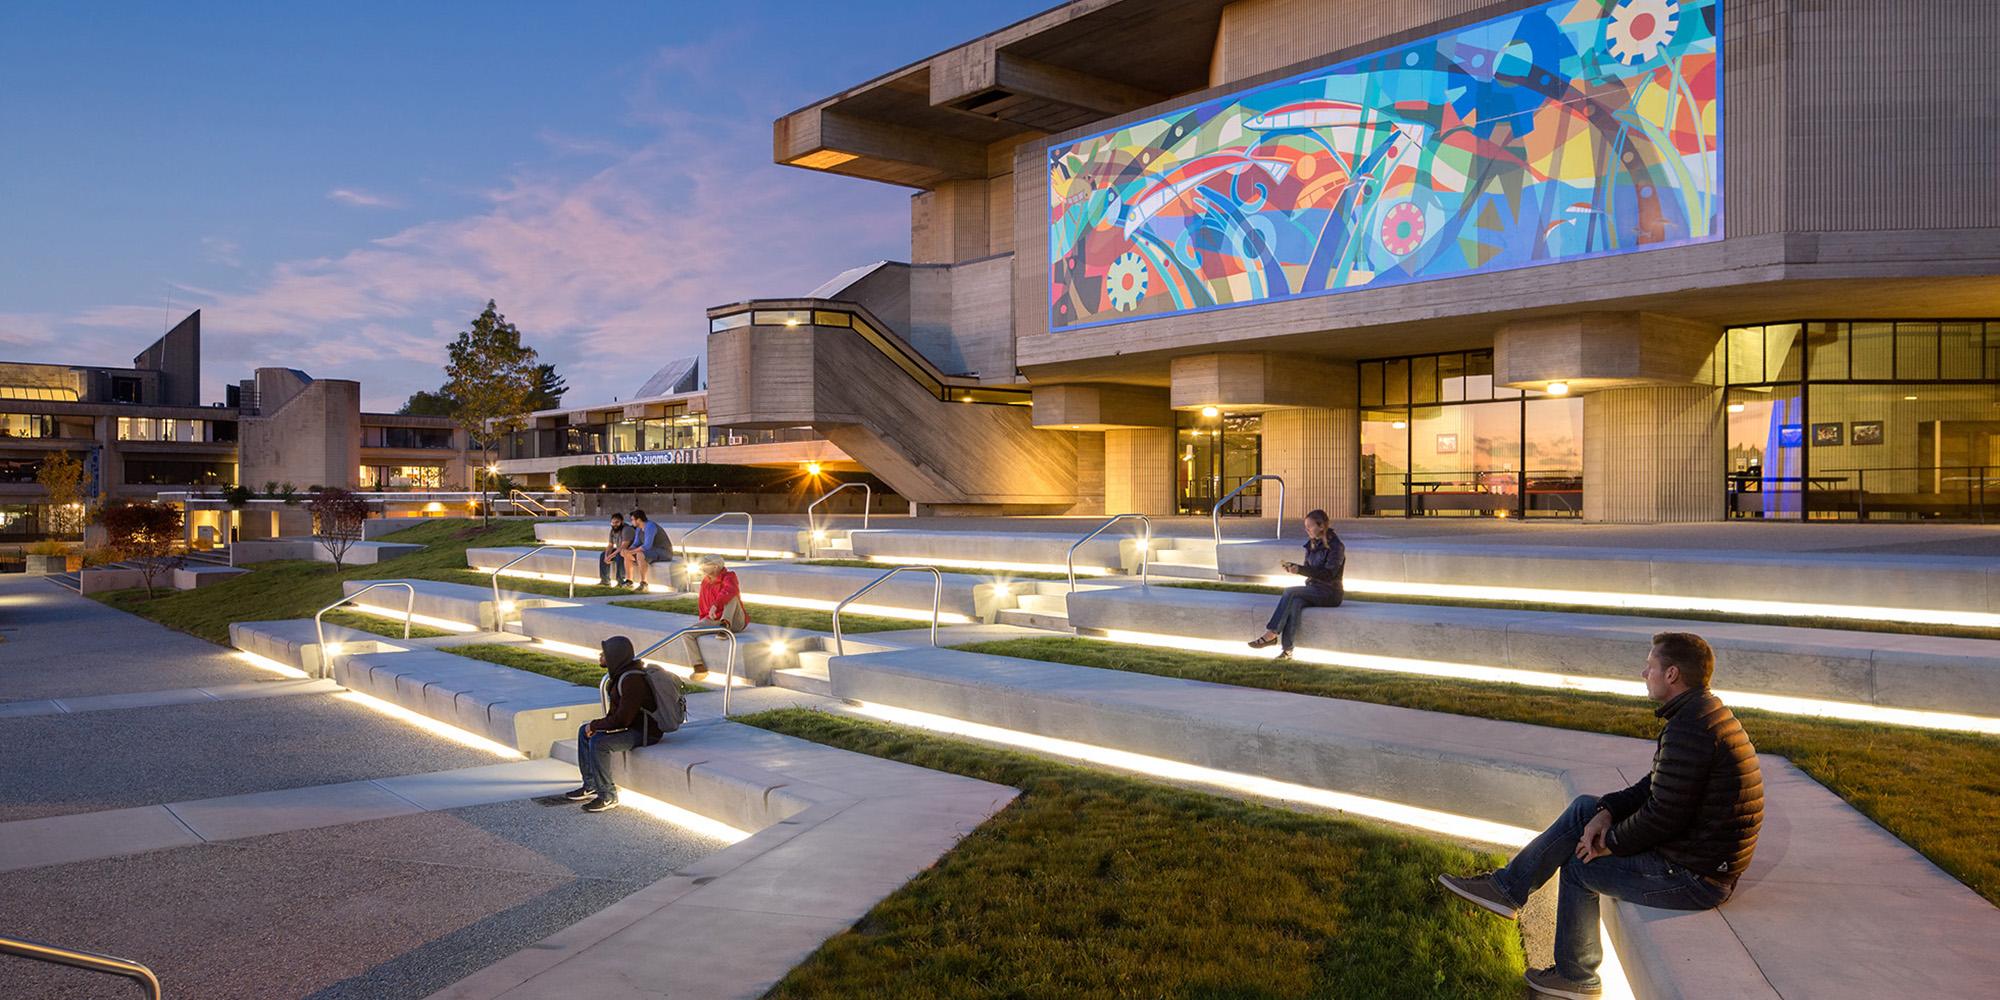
[1494,796,1730,984]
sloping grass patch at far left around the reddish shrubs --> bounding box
[96,520,544,646]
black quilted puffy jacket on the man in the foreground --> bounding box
[1600,690,1764,884]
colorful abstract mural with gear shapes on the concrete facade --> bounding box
[1048,0,1722,330]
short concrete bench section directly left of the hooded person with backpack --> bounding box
[332,650,600,756]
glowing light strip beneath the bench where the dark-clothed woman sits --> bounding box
[1086,628,2000,734]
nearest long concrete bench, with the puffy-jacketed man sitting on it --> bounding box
[832,650,2000,1000]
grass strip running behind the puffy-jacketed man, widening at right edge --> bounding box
[958,638,2000,904]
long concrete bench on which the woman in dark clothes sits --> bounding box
[1068,586,2000,716]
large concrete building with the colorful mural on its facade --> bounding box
[708,0,2000,522]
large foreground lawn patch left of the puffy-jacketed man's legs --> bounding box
[738,710,1522,1000]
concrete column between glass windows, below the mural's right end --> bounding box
[1584,386,1724,524]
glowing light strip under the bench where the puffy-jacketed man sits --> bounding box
[850,702,1632,1000]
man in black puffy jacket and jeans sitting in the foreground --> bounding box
[1438,632,1764,1000]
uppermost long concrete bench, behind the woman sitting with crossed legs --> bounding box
[1216,538,2000,614]
